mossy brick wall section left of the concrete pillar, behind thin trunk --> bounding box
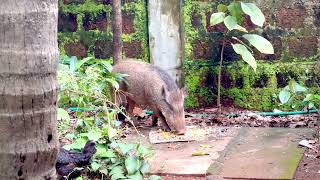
[58,0,149,60]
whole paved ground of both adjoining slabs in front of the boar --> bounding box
[124,127,312,180]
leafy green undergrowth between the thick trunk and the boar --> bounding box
[58,57,161,180]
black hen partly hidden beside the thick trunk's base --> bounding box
[56,141,97,180]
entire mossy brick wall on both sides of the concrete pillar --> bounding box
[59,0,320,110]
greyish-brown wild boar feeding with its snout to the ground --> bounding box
[113,60,186,134]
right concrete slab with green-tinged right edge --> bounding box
[209,128,313,179]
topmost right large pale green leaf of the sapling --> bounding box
[241,2,265,27]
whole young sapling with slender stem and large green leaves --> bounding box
[210,2,274,114]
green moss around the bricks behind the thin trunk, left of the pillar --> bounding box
[58,0,150,61]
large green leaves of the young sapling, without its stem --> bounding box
[210,2,274,70]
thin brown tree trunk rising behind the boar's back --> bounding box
[112,0,122,64]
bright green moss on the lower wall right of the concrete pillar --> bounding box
[184,58,319,111]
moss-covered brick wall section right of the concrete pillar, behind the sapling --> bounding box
[183,0,320,110]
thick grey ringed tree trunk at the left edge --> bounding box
[0,0,58,180]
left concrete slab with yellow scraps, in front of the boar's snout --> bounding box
[125,127,239,176]
